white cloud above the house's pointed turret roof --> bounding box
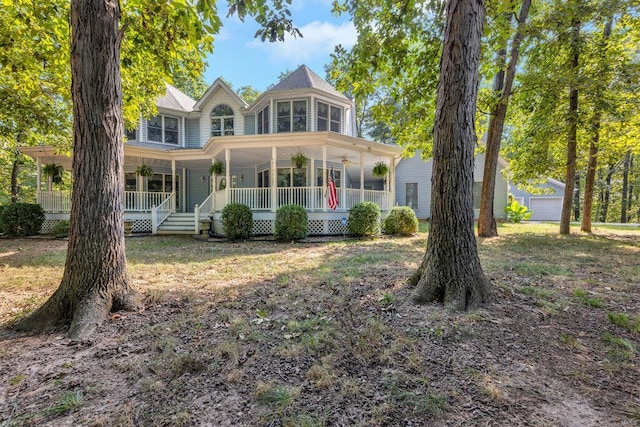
[247,21,357,65]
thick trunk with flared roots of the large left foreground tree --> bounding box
[17,0,140,339]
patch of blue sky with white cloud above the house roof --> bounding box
[204,0,356,91]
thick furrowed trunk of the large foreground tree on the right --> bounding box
[410,0,489,310]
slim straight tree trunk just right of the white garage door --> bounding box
[560,19,580,234]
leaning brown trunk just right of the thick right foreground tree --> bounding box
[478,0,531,237]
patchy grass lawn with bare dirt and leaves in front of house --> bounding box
[0,224,640,427]
